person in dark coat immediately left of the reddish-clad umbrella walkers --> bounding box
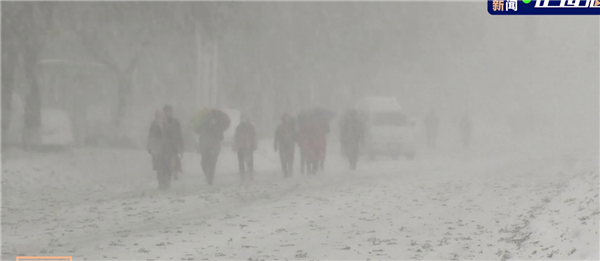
[273,113,296,177]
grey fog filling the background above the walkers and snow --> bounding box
[2,1,599,150]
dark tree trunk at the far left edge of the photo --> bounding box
[0,43,19,133]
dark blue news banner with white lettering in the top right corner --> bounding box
[488,0,600,15]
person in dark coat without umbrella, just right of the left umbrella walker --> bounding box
[233,114,257,182]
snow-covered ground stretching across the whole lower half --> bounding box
[2,139,600,260]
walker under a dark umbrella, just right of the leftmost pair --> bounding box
[198,109,231,185]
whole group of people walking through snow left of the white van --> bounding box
[147,105,364,188]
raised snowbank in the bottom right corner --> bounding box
[520,155,600,260]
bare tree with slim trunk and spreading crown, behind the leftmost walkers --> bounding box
[73,3,154,127]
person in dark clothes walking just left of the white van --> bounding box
[340,110,365,170]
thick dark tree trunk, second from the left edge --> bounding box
[22,44,42,147]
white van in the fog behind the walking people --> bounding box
[356,97,416,159]
